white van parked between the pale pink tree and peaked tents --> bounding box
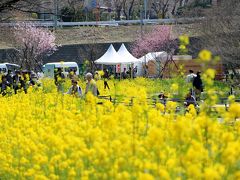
[43,62,79,78]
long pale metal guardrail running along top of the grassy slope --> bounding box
[0,18,204,27]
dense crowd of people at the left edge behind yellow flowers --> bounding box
[0,70,41,96]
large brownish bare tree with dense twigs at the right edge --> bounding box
[199,0,240,79]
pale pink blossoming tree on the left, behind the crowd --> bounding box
[13,23,57,70]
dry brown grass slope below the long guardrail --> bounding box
[0,25,198,49]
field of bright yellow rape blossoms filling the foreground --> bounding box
[0,70,240,180]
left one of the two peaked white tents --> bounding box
[95,44,122,65]
